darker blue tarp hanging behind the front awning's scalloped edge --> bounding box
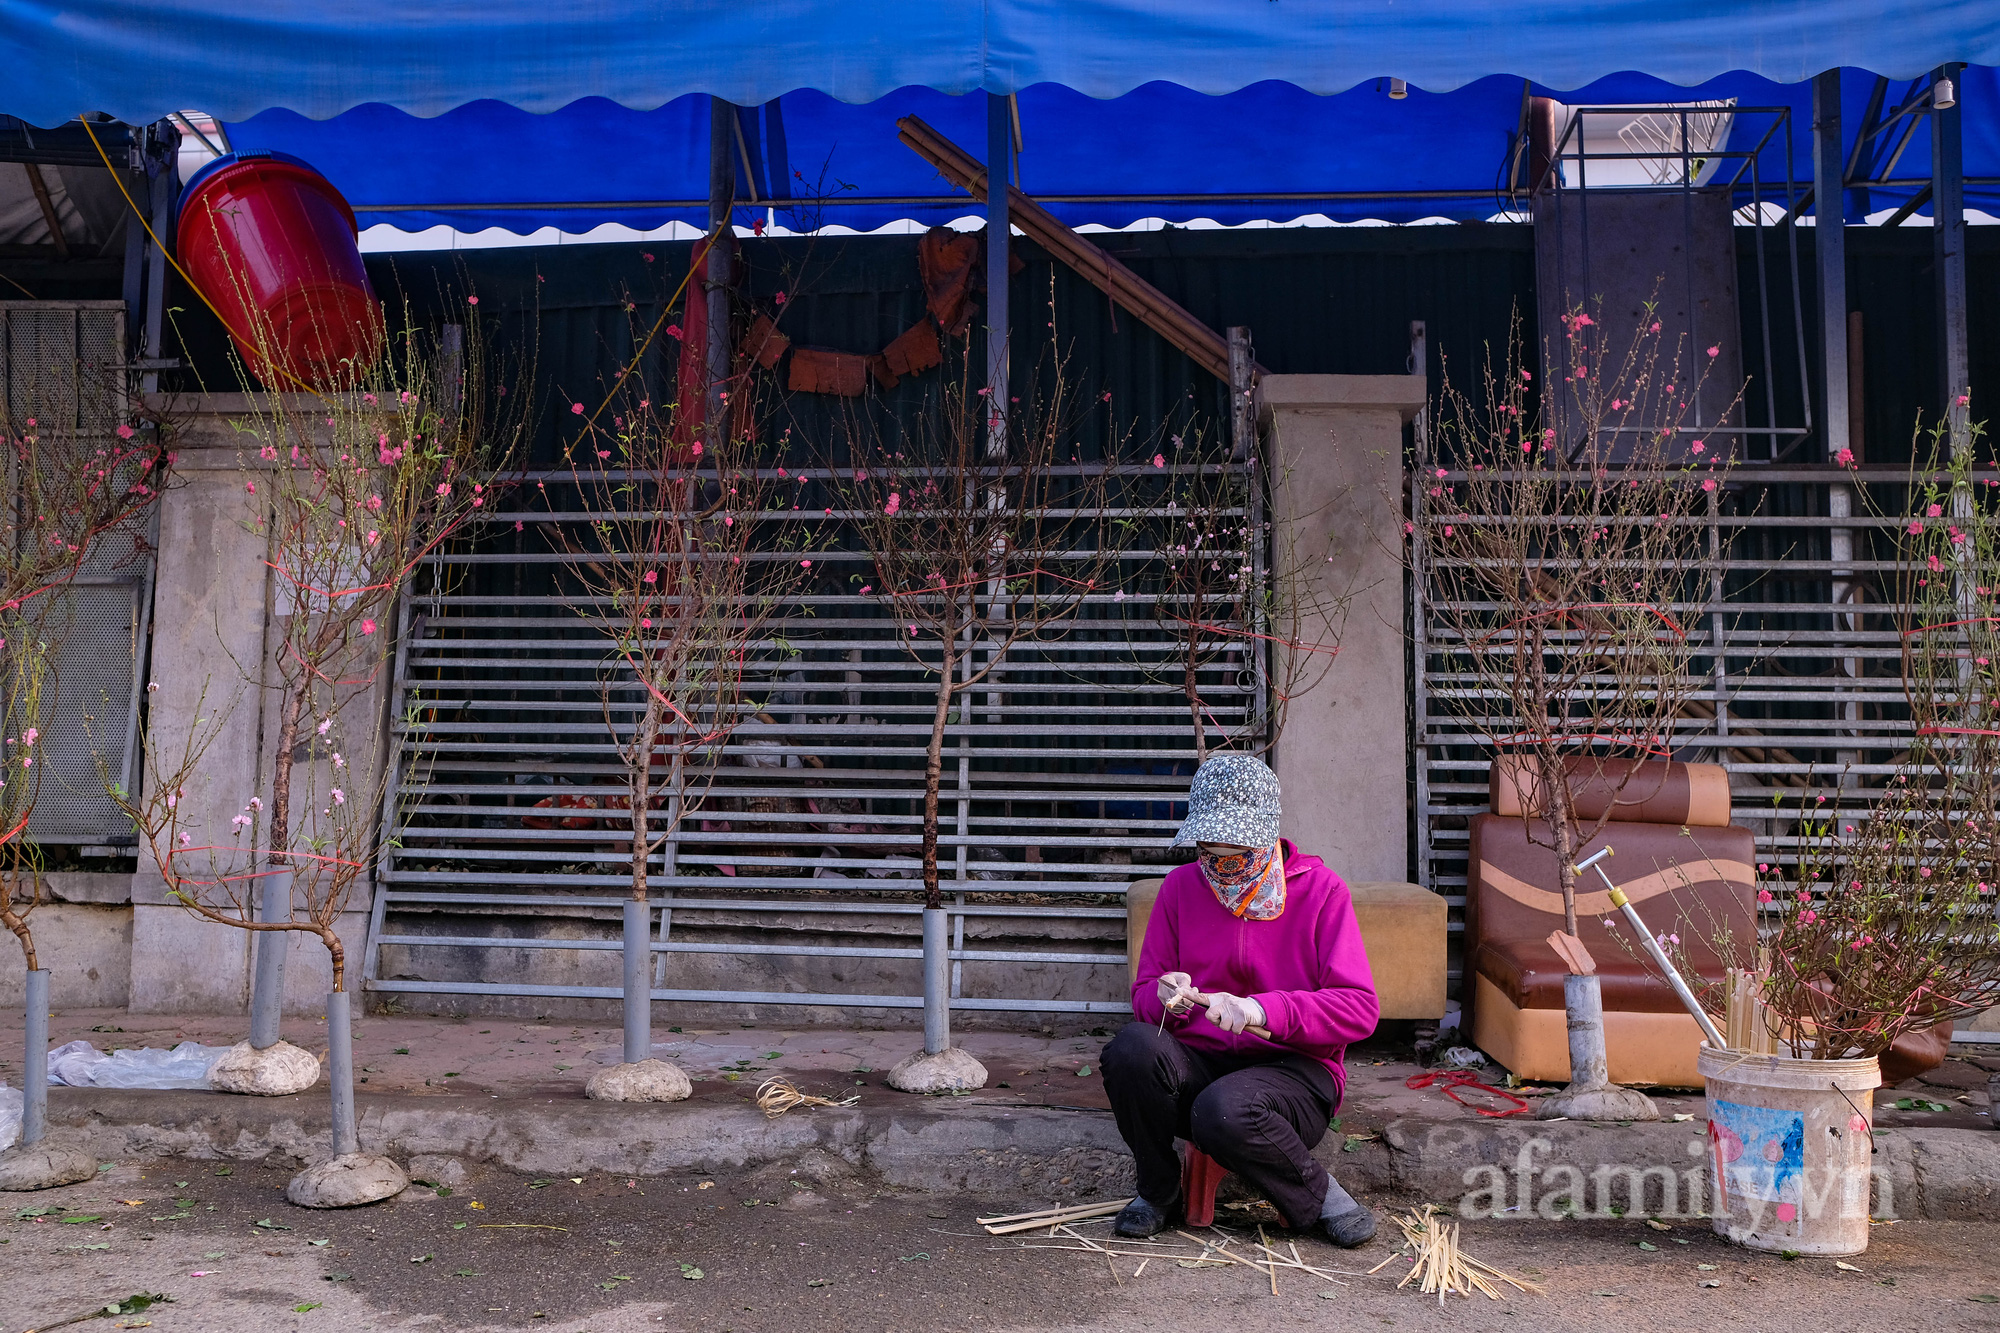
[228,68,2000,234]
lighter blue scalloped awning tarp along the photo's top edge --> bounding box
[0,0,2000,124]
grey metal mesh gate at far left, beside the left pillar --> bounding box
[0,300,152,845]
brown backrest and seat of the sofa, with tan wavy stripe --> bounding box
[1466,815,1756,1013]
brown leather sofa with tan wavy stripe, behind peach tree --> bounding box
[1464,757,1756,1087]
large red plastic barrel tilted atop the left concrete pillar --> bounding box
[178,152,382,390]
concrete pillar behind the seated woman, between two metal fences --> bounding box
[1258,374,1424,883]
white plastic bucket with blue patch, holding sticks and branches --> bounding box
[1696,1045,1882,1255]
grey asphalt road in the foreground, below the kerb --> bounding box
[0,1161,2000,1333]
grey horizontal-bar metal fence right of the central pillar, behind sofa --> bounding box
[1410,464,1952,981]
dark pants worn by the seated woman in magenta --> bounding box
[1102,1023,1338,1227]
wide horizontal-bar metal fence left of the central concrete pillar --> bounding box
[366,464,1262,1013]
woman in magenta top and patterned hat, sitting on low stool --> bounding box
[1102,755,1380,1247]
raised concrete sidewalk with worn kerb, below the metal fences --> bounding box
[11,1011,2000,1221]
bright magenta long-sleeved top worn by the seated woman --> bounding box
[1132,841,1382,1093]
